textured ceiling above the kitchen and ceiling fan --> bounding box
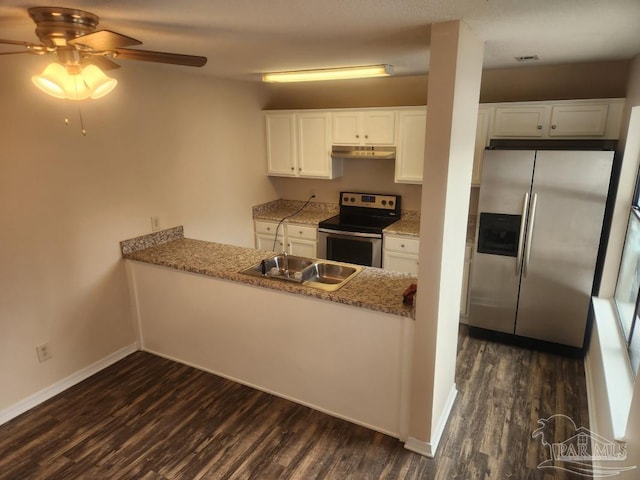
[0,0,640,80]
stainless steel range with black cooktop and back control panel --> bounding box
[318,192,401,267]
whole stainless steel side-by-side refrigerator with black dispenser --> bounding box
[468,150,614,348]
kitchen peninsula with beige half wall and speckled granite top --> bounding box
[121,227,415,439]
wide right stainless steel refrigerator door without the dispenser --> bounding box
[516,151,613,347]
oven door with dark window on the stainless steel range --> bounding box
[318,228,382,267]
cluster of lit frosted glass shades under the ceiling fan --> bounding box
[31,63,118,100]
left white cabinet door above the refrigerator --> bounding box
[492,106,549,137]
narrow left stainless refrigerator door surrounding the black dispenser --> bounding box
[467,150,535,333]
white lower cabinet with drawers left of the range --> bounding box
[255,220,318,258]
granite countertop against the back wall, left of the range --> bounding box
[253,199,339,225]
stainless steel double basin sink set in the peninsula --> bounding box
[240,253,363,292]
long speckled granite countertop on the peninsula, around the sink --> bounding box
[120,227,416,318]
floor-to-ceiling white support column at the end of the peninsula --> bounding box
[405,21,484,457]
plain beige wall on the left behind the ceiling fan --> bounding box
[0,56,275,411]
